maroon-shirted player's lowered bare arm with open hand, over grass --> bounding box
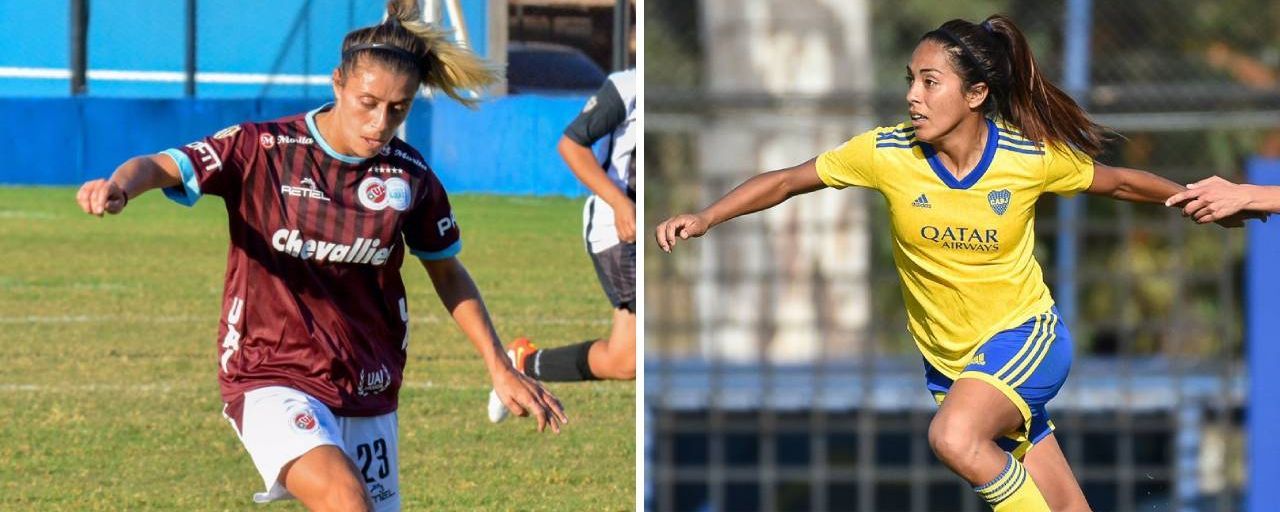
[422,257,568,434]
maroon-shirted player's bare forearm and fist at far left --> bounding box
[76,155,182,216]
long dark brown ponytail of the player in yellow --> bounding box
[920,14,1112,157]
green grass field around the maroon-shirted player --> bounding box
[0,187,635,511]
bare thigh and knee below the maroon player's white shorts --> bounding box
[280,444,374,512]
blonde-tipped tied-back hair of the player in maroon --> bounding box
[338,0,502,106]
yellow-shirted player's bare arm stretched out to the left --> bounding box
[654,159,827,252]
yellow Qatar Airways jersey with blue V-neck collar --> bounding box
[817,119,1093,379]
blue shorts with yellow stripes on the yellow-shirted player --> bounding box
[924,307,1071,458]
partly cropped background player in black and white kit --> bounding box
[489,69,640,421]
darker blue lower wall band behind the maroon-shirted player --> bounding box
[0,96,586,196]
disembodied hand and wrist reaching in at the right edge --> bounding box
[1165,175,1280,224]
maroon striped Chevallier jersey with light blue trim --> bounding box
[164,105,462,416]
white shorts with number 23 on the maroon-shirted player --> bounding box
[223,387,401,511]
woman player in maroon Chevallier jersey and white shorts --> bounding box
[77,0,567,511]
